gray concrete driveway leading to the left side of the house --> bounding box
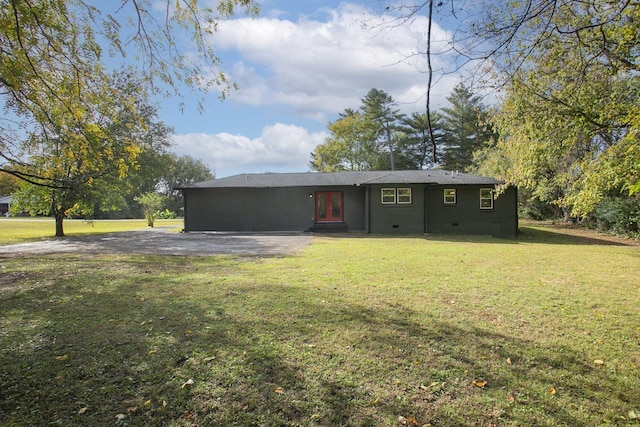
[0,227,313,256]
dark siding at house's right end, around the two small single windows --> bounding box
[426,185,518,237]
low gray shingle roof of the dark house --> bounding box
[183,169,501,188]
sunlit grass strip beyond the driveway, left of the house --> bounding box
[0,217,183,245]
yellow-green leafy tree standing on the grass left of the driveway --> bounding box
[13,73,165,236]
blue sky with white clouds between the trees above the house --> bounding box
[161,0,472,177]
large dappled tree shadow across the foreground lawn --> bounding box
[0,271,640,426]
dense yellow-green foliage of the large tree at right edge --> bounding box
[472,0,640,224]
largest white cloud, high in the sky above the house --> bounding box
[206,3,455,118]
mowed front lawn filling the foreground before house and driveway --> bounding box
[0,225,640,426]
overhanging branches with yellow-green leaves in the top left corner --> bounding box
[0,0,257,187]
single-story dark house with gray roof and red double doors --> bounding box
[181,170,518,237]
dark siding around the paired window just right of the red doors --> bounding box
[370,184,425,234]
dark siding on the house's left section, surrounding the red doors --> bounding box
[183,187,365,231]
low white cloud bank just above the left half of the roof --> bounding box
[173,123,327,177]
